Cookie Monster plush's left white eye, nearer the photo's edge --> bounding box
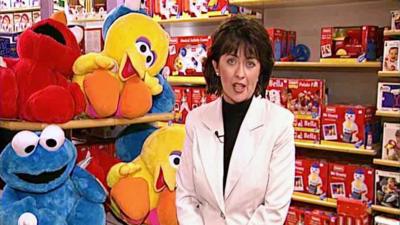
[11,130,39,157]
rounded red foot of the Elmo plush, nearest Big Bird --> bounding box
[20,85,75,123]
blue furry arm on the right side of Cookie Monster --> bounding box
[71,166,106,203]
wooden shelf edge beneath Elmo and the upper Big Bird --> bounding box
[0,113,175,130]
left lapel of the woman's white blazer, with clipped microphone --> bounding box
[199,98,225,213]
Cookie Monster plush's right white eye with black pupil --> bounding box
[40,125,65,151]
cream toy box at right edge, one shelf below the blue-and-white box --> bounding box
[382,123,400,162]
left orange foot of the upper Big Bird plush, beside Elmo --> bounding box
[83,70,120,118]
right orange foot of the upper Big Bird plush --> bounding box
[117,77,152,118]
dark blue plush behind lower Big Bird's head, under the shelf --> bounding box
[115,123,157,162]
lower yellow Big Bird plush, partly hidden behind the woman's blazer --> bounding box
[107,126,185,225]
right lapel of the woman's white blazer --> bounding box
[225,97,265,199]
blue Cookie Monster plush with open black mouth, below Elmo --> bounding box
[0,125,106,225]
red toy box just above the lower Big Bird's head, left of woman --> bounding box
[173,87,192,123]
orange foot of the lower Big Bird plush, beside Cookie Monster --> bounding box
[110,177,150,224]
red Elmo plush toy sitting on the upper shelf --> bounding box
[0,19,86,123]
